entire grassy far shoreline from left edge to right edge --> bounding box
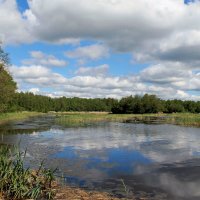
[0,111,200,127]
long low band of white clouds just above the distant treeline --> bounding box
[9,65,200,100]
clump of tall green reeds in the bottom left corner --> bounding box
[0,146,55,200]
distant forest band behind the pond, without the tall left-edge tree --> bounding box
[4,92,200,114]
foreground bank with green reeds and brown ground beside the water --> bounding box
[0,146,118,200]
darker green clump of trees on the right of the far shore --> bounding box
[112,94,200,114]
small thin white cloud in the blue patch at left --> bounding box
[22,51,68,67]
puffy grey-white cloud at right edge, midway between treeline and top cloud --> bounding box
[140,62,200,91]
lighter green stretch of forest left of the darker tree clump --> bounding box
[9,92,117,112]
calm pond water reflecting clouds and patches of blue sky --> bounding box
[0,117,200,200]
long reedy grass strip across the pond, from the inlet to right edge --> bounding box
[56,113,200,127]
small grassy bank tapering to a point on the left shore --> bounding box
[0,112,43,124]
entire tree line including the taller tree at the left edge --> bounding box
[0,46,200,114]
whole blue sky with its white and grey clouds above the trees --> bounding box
[0,0,200,100]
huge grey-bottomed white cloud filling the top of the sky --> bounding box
[21,0,200,51]
